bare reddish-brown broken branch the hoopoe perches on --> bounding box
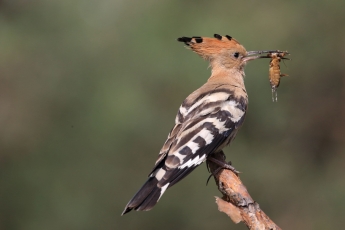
[207,151,281,230]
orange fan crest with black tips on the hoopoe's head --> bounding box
[177,34,246,60]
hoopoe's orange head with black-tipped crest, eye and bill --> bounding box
[177,34,269,70]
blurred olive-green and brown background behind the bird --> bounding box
[0,0,345,230]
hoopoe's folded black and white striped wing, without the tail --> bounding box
[150,97,245,189]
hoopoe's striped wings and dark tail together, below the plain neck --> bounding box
[122,92,247,214]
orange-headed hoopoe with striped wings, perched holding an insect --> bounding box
[122,34,269,215]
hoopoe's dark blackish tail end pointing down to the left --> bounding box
[121,177,165,215]
